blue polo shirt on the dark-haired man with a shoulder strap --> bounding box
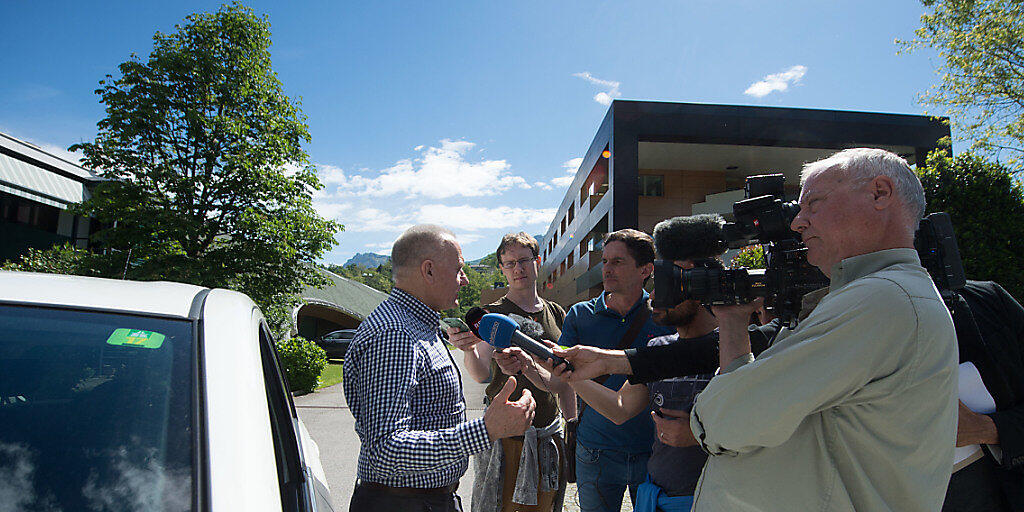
[558,291,676,454]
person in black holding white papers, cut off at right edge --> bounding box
[942,281,1024,512]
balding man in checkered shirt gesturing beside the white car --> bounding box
[344,224,536,511]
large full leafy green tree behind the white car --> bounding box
[9,3,341,335]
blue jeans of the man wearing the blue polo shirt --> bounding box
[575,442,650,512]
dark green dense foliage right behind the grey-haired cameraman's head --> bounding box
[918,151,1024,299]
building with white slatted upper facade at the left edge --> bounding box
[0,133,100,262]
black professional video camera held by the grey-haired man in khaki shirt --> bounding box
[653,174,828,327]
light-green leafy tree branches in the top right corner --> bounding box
[897,0,1024,167]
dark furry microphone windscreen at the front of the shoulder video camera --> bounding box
[653,213,728,261]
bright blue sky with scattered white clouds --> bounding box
[0,0,937,263]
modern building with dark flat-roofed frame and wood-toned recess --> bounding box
[539,100,949,306]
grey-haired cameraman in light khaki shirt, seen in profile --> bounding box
[690,148,956,511]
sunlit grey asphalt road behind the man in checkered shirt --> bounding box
[295,350,484,510]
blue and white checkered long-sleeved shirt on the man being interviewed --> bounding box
[344,288,490,488]
